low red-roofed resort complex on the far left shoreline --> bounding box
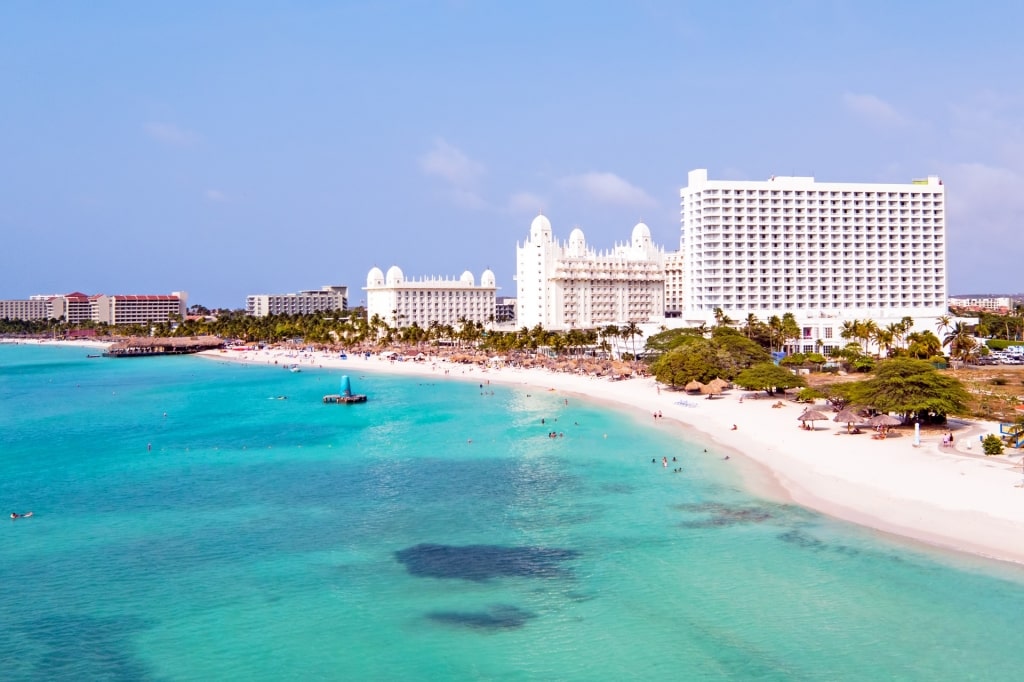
[0,291,188,325]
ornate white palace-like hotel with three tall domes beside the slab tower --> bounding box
[516,215,665,330]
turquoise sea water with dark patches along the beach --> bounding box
[0,345,1024,680]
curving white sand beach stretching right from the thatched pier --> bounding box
[190,349,1024,563]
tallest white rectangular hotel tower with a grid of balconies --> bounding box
[680,169,947,350]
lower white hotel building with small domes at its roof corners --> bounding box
[364,265,498,329]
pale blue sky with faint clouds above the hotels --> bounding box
[0,0,1024,308]
